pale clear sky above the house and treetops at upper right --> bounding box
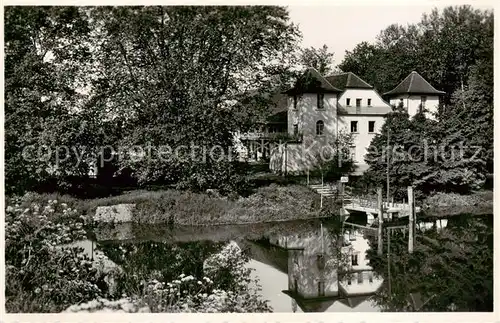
[288,2,492,65]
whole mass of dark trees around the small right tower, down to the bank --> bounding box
[346,6,493,198]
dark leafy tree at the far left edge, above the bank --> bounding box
[5,7,103,193]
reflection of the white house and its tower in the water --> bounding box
[270,228,383,312]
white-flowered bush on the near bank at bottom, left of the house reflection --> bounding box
[68,243,271,313]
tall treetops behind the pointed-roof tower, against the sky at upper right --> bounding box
[339,5,493,104]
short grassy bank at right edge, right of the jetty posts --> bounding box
[421,190,494,218]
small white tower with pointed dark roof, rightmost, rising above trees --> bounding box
[384,71,445,118]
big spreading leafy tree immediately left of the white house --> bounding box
[89,6,297,195]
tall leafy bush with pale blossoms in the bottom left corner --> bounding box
[5,196,104,312]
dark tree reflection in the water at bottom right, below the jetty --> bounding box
[368,215,493,311]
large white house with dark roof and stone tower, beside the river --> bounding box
[270,68,392,174]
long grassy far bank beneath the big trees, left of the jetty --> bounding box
[15,184,336,225]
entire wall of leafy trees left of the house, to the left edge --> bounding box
[5,6,298,196]
